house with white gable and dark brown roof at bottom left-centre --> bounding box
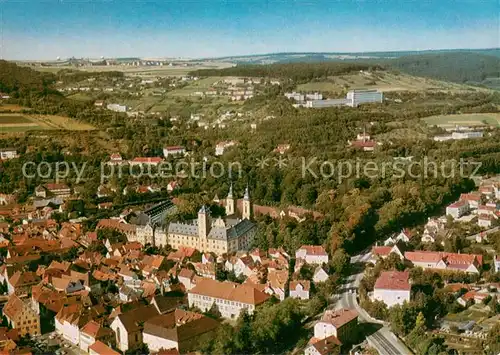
[110,305,159,352]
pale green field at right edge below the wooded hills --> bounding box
[423,113,500,128]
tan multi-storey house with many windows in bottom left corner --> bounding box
[2,294,41,336]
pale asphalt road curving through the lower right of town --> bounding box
[336,252,412,355]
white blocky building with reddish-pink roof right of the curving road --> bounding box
[373,271,411,307]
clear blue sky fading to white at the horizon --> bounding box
[0,0,500,60]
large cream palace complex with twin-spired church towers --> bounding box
[167,185,257,255]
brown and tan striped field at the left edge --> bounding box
[0,113,95,133]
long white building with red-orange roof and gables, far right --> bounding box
[404,251,483,274]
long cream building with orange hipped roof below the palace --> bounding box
[188,279,270,319]
